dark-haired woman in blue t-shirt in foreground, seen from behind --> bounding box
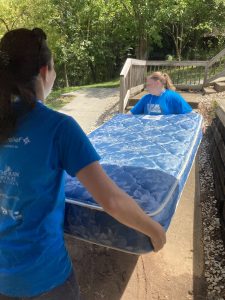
[0,28,166,300]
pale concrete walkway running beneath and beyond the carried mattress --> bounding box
[61,89,205,300]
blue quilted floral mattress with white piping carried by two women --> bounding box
[64,112,202,254]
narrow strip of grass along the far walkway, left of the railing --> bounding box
[46,79,120,110]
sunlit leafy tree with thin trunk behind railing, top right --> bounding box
[157,0,225,60]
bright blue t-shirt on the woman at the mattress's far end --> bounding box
[131,90,192,115]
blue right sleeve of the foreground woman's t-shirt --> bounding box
[57,116,100,177]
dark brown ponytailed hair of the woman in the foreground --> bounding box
[0,28,51,144]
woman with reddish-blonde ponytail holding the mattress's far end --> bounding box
[131,72,192,115]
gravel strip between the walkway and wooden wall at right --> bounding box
[199,92,225,300]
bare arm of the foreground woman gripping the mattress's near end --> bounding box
[76,162,166,251]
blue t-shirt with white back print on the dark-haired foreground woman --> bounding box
[0,102,100,297]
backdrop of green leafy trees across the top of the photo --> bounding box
[0,0,225,88]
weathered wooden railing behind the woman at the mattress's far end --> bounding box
[119,49,225,113]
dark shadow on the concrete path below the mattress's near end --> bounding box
[67,237,139,300]
